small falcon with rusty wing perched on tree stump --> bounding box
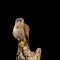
[13,18,30,46]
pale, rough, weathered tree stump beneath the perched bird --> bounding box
[16,43,41,60]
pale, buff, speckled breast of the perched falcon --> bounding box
[13,27,25,39]
